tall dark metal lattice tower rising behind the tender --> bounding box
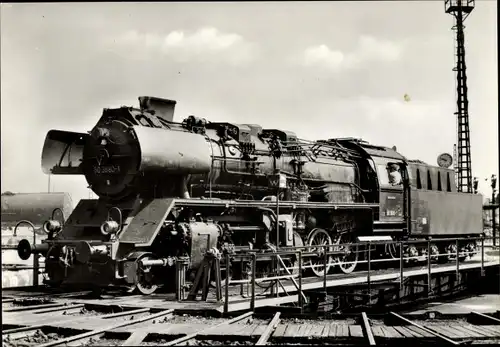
[444,0,474,193]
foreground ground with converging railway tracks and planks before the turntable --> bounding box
[2,292,500,347]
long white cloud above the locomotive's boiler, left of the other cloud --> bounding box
[106,27,257,65]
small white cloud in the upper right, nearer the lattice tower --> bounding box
[300,36,403,71]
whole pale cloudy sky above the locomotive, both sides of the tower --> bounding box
[0,0,499,203]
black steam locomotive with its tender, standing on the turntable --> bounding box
[18,97,482,294]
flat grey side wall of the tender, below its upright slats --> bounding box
[412,190,482,235]
